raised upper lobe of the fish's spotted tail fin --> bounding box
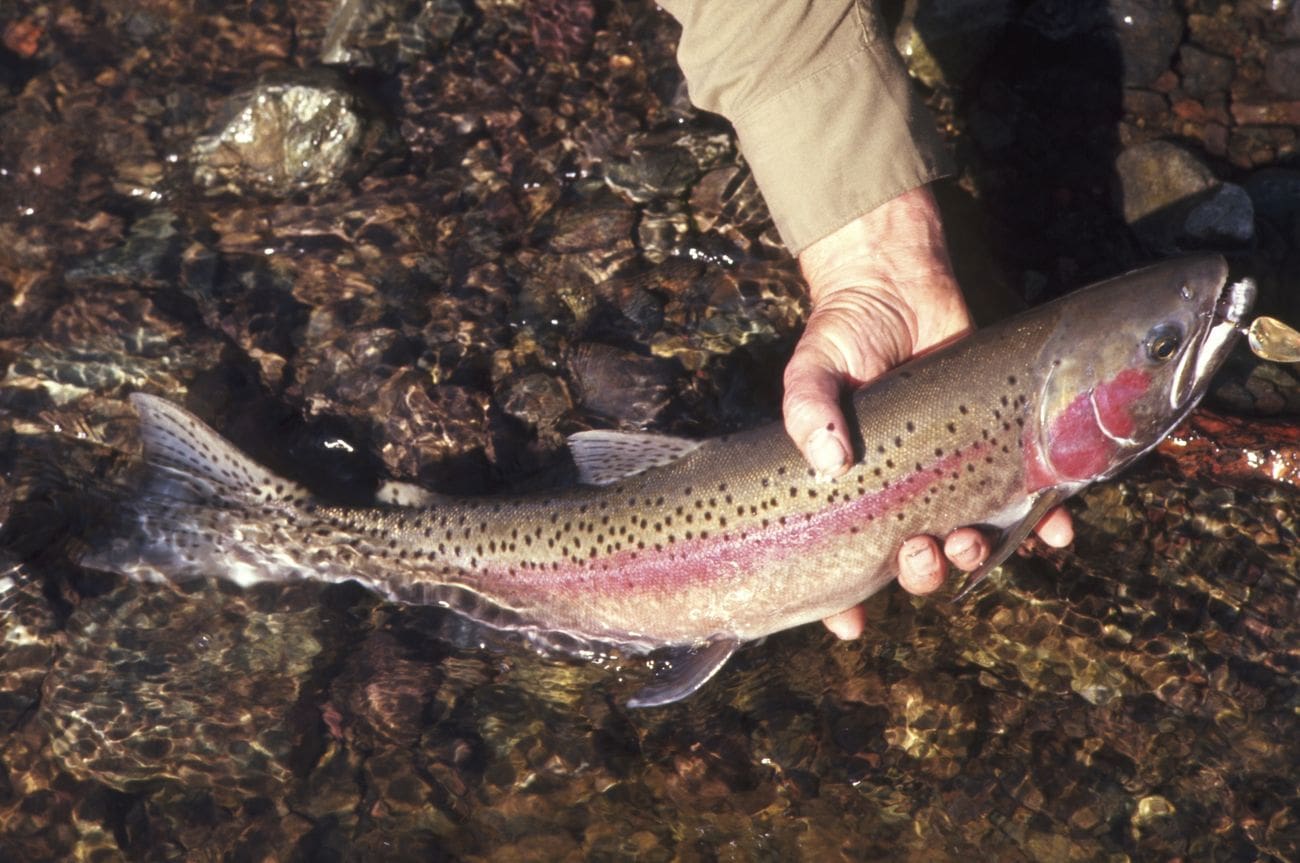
[131,393,311,504]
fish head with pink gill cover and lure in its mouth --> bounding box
[1023,255,1255,491]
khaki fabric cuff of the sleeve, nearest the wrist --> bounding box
[731,40,953,255]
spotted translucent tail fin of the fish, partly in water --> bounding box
[81,393,319,585]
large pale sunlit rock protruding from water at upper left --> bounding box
[190,70,386,198]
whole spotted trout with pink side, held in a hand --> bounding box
[83,256,1255,706]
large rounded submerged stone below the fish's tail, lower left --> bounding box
[40,585,320,806]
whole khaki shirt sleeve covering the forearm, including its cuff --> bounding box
[663,0,950,255]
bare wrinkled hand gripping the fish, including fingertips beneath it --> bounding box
[783,187,1074,638]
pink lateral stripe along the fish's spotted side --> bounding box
[491,442,991,595]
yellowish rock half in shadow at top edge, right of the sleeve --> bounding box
[894,0,1011,87]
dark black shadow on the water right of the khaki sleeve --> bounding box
[884,0,1138,311]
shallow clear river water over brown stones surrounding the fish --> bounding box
[0,0,1300,860]
